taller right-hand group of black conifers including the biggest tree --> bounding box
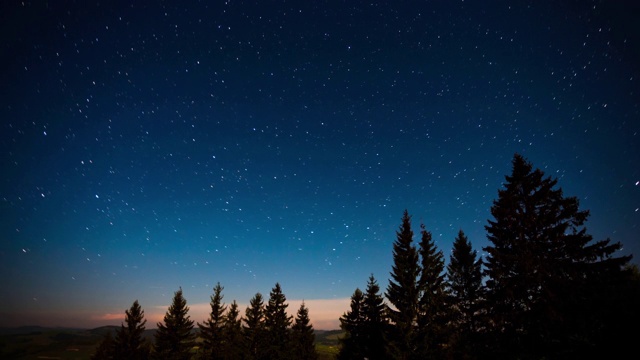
[338,154,640,360]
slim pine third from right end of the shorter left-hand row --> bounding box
[242,293,268,360]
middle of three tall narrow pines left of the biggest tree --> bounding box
[416,224,449,359]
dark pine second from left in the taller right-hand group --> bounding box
[362,274,389,360]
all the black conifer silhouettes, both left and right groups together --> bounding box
[92,154,640,360]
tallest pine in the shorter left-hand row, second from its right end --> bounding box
[265,283,292,359]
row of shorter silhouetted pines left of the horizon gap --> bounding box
[92,283,318,360]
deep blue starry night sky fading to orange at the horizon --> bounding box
[0,0,640,329]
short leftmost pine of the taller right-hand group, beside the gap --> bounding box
[338,288,365,360]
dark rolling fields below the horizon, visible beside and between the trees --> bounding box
[0,326,343,360]
